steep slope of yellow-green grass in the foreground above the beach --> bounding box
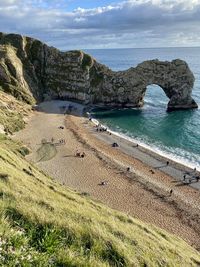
[0,135,200,267]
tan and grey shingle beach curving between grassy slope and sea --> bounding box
[14,101,200,250]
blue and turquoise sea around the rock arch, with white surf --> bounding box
[85,47,200,170]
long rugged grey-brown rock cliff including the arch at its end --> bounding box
[0,33,197,110]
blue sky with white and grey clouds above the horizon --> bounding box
[0,0,200,50]
